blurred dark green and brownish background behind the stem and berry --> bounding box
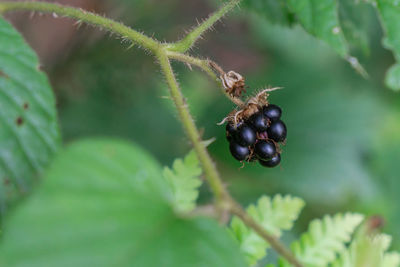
[5,0,400,248]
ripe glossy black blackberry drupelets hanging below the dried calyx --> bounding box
[226,105,287,168]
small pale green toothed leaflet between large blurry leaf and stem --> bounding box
[163,150,202,212]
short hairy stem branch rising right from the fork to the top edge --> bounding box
[166,0,240,53]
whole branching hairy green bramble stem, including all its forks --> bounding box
[0,0,302,267]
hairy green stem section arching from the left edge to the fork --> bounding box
[0,2,160,53]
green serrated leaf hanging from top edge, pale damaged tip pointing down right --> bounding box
[243,0,368,77]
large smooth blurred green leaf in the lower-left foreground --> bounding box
[0,140,244,267]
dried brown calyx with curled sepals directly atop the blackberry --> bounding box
[219,87,281,126]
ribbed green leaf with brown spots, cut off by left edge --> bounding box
[0,18,60,215]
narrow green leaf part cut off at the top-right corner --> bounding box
[376,0,400,91]
